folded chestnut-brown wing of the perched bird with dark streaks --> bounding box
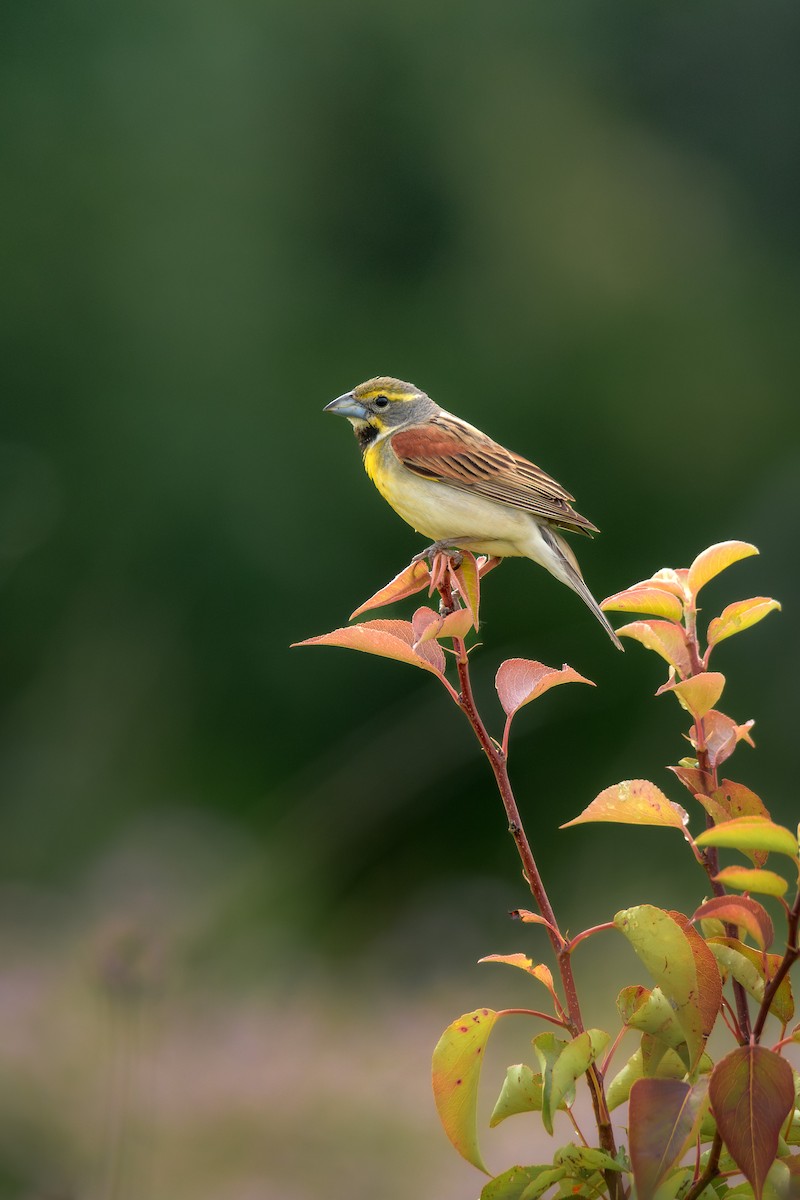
[391,412,597,534]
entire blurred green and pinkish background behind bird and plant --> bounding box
[0,0,800,1200]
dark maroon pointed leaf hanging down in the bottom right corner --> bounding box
[709,1045,794,1200]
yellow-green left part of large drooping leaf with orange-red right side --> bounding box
[614,905,705,1063]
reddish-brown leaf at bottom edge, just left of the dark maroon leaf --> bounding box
[628,1079,708,1200]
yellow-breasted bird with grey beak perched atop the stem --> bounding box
[324,376,624,650]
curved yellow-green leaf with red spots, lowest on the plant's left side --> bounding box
[433,1008,498,1175]
